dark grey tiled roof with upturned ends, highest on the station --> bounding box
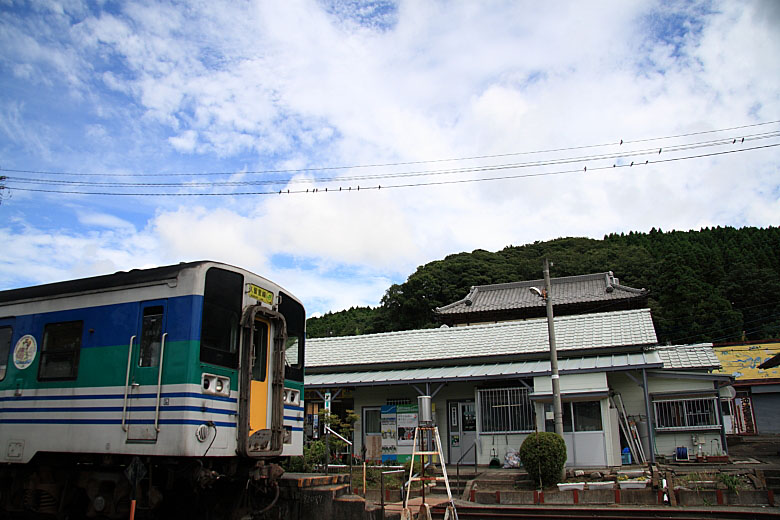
[435,271,648,316]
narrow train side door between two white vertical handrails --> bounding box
[125,300,168,442]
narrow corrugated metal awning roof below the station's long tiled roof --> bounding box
[306,350,663,388]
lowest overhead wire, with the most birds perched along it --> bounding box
[7,143,780,197]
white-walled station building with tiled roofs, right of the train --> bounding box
[306,273,732,467]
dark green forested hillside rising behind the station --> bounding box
[307,227,780,343]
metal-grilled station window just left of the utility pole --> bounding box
[478,387,534,433]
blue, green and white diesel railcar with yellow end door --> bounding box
[0,261,306,518]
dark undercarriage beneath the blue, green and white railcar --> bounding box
[0,453,283,520]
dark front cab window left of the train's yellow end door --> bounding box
[200,267,244,368]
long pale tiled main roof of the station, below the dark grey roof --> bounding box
[306,309,657,368]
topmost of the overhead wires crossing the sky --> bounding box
[0,120,780,177]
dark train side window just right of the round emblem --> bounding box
[38,321,84,380]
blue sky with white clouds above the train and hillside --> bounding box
[0,0,780,314]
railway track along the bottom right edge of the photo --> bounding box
[431,504,780,520]
